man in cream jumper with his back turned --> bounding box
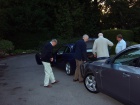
[93,33,113,59]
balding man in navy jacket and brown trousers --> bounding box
[73,35,89,83]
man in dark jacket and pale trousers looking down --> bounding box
[41,39,58,88]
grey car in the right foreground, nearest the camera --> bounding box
[81,44,140,105]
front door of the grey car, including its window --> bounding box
[101,49,140,102]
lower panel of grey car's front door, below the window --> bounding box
[101,64,130,100]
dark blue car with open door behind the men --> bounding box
[53,39,96,75]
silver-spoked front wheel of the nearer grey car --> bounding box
[84,74,98,93]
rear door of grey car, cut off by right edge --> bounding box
[130,50,140,105]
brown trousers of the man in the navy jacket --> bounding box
[74,59,83,81]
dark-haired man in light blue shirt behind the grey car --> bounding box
[115,34,126,54]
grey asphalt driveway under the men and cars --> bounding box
[0,54,122,105]
